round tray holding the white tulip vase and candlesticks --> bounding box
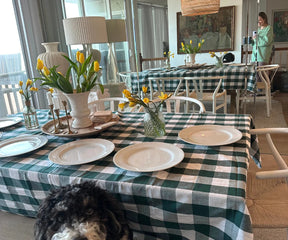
[41,114,119,138]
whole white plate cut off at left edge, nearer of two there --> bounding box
[0,135,48,157]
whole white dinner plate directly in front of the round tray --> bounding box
[48,138,115,165]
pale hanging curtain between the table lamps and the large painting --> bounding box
[137,4,168,58]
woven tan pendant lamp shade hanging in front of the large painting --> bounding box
[181,0,220,16]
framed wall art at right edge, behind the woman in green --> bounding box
[273,9,288,43]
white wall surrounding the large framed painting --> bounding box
[168,0,243,66]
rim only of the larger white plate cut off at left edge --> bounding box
[0,135,48,158]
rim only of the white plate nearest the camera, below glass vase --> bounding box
[113,142,185,172]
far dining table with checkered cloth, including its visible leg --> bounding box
[128,63,256,113]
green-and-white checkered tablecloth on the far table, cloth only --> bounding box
[131,66,255,93]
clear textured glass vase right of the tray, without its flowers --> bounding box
[143,108,166,137]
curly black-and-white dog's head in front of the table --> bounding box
[34,182,132,240]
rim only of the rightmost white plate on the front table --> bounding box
[178,125,242,146]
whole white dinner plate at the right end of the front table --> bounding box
[178,125,242,146]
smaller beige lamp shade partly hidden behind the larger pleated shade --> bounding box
[106,19,127,43]
